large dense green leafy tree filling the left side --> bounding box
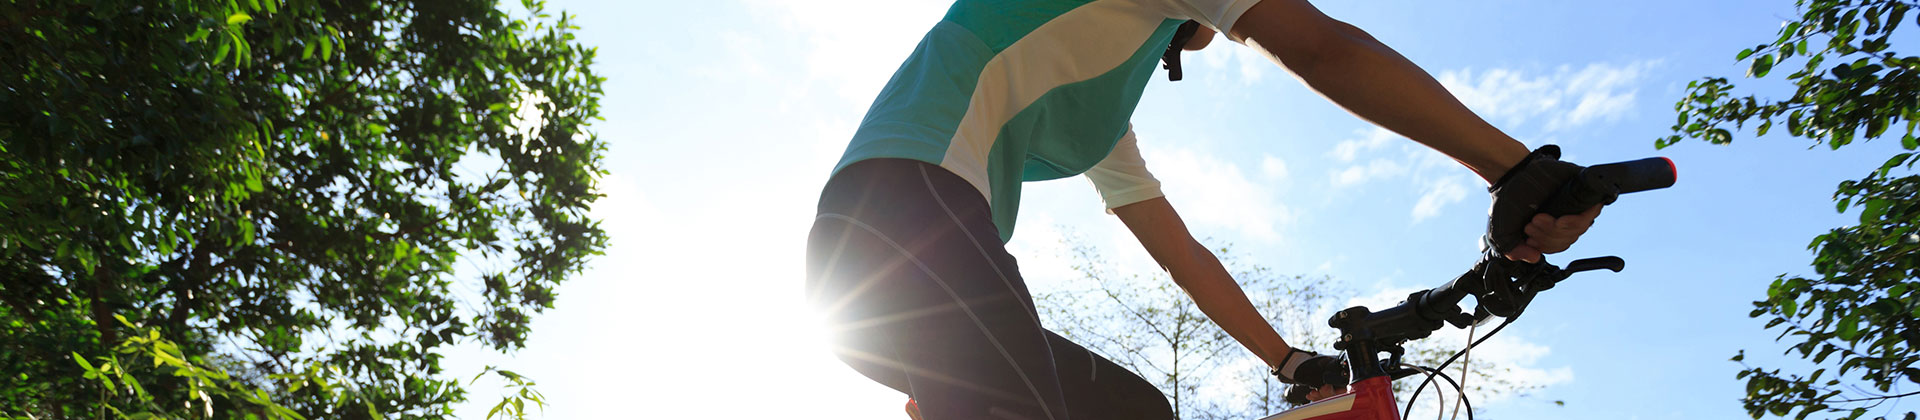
[0,0,607,418]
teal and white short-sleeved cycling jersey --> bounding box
[833,0,1260,240]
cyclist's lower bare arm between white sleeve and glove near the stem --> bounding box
[1114,198,1290,366]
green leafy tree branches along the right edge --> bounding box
[1655,0,1920,418]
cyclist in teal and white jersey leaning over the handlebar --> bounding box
[806,0,1599,420]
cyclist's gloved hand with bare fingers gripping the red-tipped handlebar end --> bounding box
[1484,144,1599,263]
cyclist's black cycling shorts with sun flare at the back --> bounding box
[806,159,1173,420]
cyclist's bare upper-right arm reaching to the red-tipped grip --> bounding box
[1233,0,1526,184]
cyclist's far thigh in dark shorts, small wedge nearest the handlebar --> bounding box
[1046,332,1173,420]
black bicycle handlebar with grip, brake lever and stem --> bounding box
[1327,157,1678,382]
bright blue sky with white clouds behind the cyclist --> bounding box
[449,0,1920,418]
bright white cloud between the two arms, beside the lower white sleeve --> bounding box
[1140,144,1294,242]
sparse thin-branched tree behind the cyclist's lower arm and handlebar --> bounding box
[1035,238,1540,420]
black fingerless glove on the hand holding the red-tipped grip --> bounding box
[1480,144,1582,255]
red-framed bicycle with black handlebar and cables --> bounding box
[1261,157,1676,420]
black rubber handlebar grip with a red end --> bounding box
[1540,157,1678,217]
